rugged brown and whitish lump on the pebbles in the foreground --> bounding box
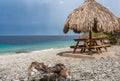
[28,62,68,81]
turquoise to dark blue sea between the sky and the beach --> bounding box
[0,36,79,54]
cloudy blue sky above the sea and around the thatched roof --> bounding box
[0,0,120,35]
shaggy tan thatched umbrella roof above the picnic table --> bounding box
[64,0,120,33]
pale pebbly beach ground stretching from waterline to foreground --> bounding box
[0,46,120,81]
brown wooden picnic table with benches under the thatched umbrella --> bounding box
[70,37,111,53]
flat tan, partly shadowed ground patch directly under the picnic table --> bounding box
[57,51,109,59]
